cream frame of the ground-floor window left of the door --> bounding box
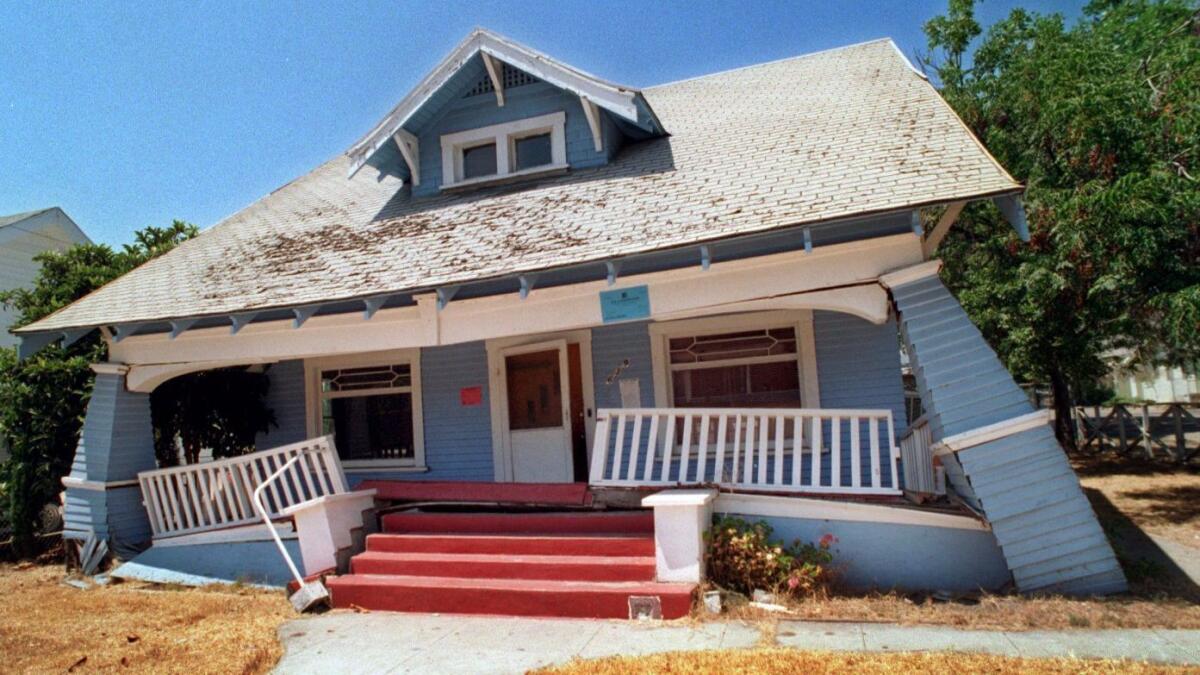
[304,350,428,473]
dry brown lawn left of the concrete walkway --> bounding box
[0,565,292,674]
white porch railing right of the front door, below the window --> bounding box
[590,408,900,495]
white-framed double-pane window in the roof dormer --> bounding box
[442,112,566,189]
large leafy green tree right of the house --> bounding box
[925,0,1200,448]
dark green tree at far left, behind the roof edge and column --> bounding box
[0,221,198,555]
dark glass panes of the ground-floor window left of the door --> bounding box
[310,358,425,468]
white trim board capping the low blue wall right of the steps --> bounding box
[713,494,990,532]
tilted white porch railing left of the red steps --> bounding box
[138,437,347,538]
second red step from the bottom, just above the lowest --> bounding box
[350,551,655,581]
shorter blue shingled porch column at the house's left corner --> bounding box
[62,363,156,558]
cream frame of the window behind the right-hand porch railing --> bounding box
[649,310,821,410]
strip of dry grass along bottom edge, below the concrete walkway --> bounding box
[535,649,1188,675]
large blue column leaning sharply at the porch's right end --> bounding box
[880,261,1126,595]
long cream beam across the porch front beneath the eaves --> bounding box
[109,229,922,367]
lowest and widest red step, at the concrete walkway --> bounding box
[326,574,695,619]
